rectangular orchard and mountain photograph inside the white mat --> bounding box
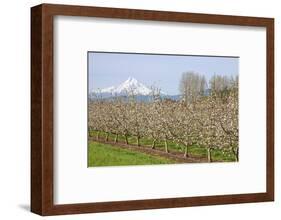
[87,51,239,167]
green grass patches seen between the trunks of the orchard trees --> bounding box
[88,131,235,162]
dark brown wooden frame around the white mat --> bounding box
[31,4,274,215]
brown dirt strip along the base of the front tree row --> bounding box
[89,138,208,163]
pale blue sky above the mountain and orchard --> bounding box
[88,52,236,95]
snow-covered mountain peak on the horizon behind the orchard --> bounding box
[92,77,152,96]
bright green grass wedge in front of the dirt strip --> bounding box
[88,141,175,167]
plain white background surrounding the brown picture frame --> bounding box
[0,0,281,220]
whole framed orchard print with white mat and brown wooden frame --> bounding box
[31,4,274,215]
